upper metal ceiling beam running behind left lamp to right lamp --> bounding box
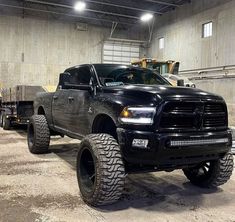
[25,0,139,20]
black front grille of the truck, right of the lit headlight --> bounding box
[159,102,227,130]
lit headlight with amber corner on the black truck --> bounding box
[119,107,156,125]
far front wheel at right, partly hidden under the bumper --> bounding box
[183,152,234,188]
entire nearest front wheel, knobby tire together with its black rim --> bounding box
[77,134,125,206]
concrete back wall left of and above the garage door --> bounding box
[0,15,146,88]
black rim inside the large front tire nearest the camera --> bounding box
[79,148,96,193]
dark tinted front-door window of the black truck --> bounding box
[70,66,91,85]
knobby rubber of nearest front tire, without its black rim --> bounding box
[78,134,125,206]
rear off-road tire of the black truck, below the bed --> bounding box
[28,115,50,154]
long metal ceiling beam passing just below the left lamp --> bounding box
[0,4,136,26]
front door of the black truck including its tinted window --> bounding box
[66,66,94,135]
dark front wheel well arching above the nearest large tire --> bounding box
[92,114,117,139]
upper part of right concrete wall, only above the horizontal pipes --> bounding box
[149,0,235,70]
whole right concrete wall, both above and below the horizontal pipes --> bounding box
[148,0,235,126]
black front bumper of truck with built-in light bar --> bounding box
[117,128,232,169]
